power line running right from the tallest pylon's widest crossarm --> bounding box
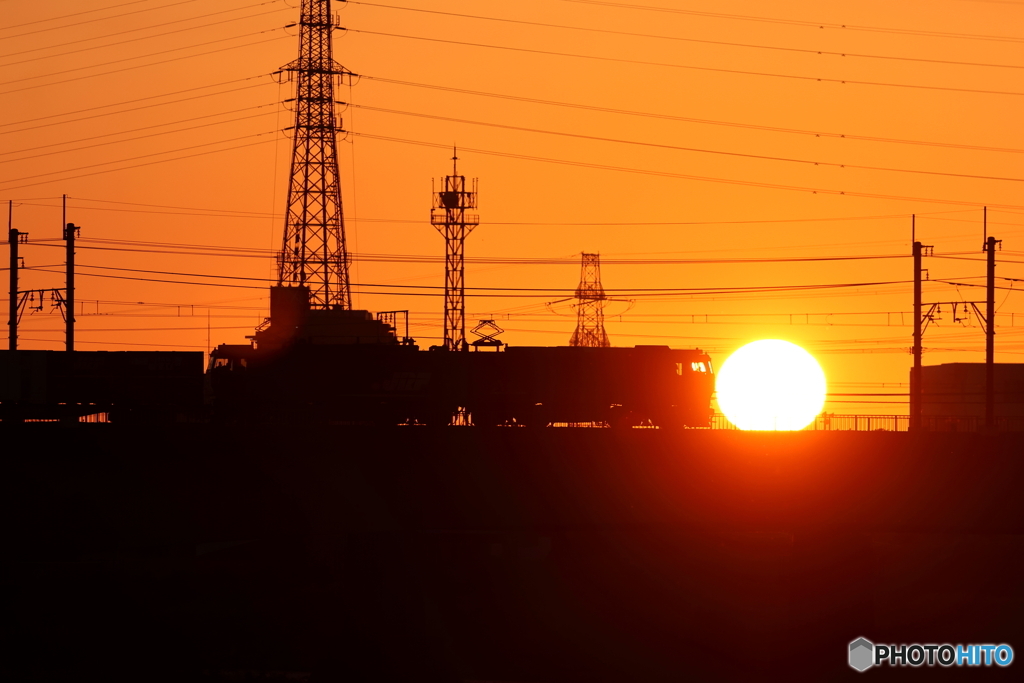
[360,75,1024,154]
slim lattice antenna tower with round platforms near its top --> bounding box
[430,154,480,351]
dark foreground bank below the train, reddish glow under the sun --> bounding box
[0,424,1024,682]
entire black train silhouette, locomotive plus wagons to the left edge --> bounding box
[0,287,715,427]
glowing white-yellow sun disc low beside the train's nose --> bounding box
[715,339,825,431]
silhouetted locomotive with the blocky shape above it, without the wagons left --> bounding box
[207,287,715,427]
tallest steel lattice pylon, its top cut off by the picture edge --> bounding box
[278,0,352,309]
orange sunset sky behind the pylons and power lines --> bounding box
[0,0,1024,414]
